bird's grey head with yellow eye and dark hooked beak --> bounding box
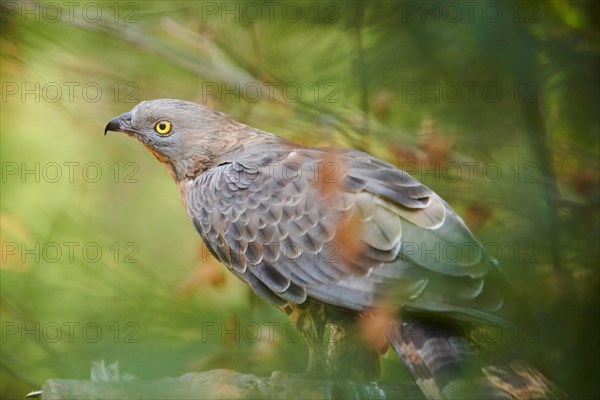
[104,99,244,179]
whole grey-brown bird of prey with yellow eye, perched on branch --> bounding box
[104,99,556,399]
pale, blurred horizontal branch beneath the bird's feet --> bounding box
[37,369,423,400]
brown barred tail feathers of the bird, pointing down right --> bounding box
[387,321,567,399]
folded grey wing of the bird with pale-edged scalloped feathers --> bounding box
[187,142,503,322]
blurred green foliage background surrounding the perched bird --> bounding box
[0,1,600,398]
